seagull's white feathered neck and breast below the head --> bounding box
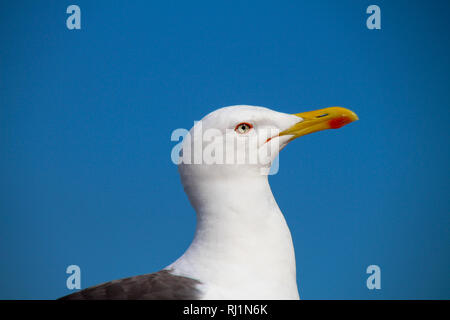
[171,171,298,299]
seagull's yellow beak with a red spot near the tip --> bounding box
[280,107,359,140]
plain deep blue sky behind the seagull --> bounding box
[0,1,450,299]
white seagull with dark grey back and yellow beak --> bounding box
[60,105,358,300]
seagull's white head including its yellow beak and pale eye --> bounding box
[179,105,358,177]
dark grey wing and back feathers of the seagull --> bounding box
[59,270,201,300]
